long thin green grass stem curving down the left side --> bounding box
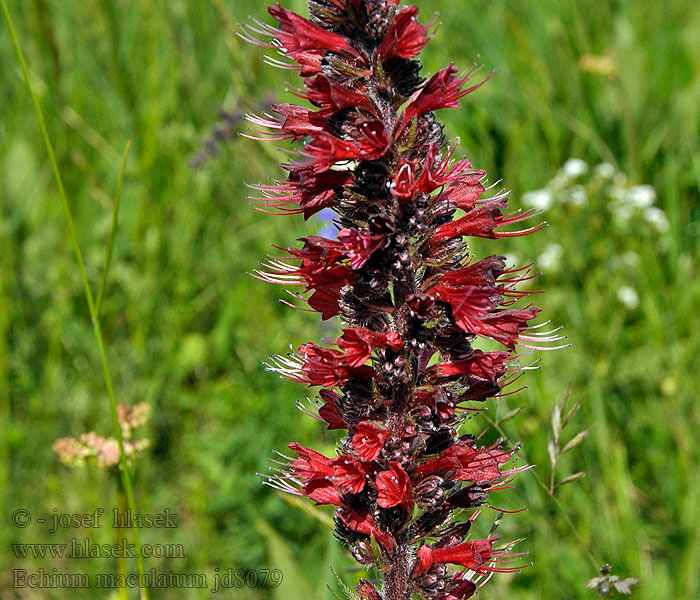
[0,0,148,600]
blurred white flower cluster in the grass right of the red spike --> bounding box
[520,158,671,312]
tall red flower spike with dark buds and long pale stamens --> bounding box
[241,0,559,600]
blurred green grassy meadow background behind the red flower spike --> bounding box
[0,0,700,600]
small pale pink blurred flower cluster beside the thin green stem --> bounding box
[52,402,151,469]
